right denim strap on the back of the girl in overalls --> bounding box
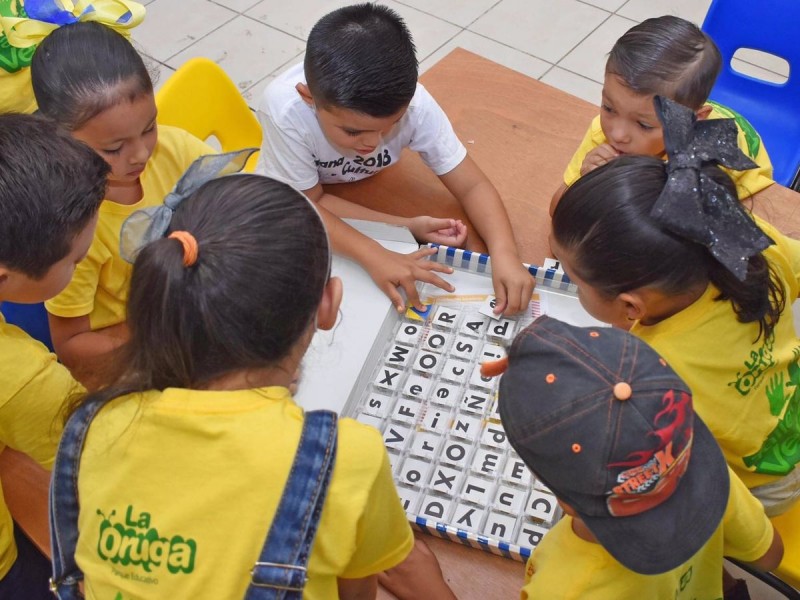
[245,410,337,600]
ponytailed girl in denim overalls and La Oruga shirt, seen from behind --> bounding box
[47,174,428,599]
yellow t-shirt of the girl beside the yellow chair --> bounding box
[45,125,214,330]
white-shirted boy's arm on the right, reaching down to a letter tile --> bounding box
[439,156,534,315]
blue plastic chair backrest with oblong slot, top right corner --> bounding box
[703,0,800,186]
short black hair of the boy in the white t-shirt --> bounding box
[304,3,418,118]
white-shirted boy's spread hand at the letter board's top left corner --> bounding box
[364,247,455,313]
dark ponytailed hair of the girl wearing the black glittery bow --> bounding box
[553,156,786,339]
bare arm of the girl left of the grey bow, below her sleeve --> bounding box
[47,313,129,379]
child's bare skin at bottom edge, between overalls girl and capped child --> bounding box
[378,538,456,600]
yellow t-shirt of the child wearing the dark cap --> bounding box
[520,466,773,600]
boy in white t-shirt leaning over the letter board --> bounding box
[257,4,533,314]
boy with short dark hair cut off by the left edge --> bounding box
[0,114,108,600]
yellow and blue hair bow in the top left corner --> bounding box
[0,0,144,48]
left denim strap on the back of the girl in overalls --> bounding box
[50,402,103,600]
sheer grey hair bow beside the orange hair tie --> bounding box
[119,148,256,263]
